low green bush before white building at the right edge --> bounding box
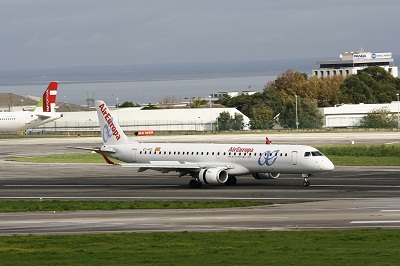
[360,108,399,128]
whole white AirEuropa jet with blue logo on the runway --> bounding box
[96,98,334,188]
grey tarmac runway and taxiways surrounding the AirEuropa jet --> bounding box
[0,133,400,235]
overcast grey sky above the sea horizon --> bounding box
[0,0,400,70]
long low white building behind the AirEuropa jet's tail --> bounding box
[38,107,250,133]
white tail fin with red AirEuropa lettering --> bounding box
[96,101,136,145]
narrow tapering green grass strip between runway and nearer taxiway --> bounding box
[0,199,268,212]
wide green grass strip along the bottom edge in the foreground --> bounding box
[0,229,400,266]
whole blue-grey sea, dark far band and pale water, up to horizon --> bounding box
[0,59,316,106]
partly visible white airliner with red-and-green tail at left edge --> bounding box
[0,81,62,132]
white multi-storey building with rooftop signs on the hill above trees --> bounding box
[312,50,399,78]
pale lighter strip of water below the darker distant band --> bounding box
[0,76,275,105]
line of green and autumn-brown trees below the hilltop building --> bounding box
[219,66,400,129]
